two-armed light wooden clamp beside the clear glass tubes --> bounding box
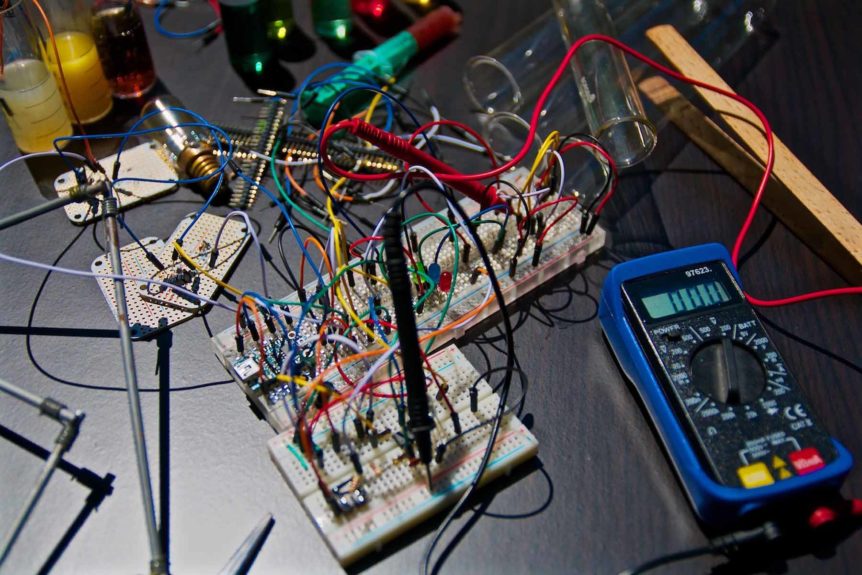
[640,25,862,285]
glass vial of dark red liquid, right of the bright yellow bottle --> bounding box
[90,0,156,99]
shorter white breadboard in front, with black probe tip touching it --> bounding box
[269,345,539,565]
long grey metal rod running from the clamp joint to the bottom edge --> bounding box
[103,196,167,575]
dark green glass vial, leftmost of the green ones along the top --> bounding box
[219,0,274,76]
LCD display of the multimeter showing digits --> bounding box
[625,262,741,321]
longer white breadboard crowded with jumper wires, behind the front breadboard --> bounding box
[213,191,605,432]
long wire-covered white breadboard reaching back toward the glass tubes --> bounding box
[213,189,605,432]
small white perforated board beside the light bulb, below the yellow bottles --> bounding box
[54,143,177,225]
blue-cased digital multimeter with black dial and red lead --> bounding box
[599,244,853,526]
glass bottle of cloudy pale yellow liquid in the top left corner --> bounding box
[0,0,72,153]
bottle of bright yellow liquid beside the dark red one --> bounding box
[34,0,114,124]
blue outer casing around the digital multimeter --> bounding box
[599,244,853,527]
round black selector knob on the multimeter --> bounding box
[691,337,766,405]
